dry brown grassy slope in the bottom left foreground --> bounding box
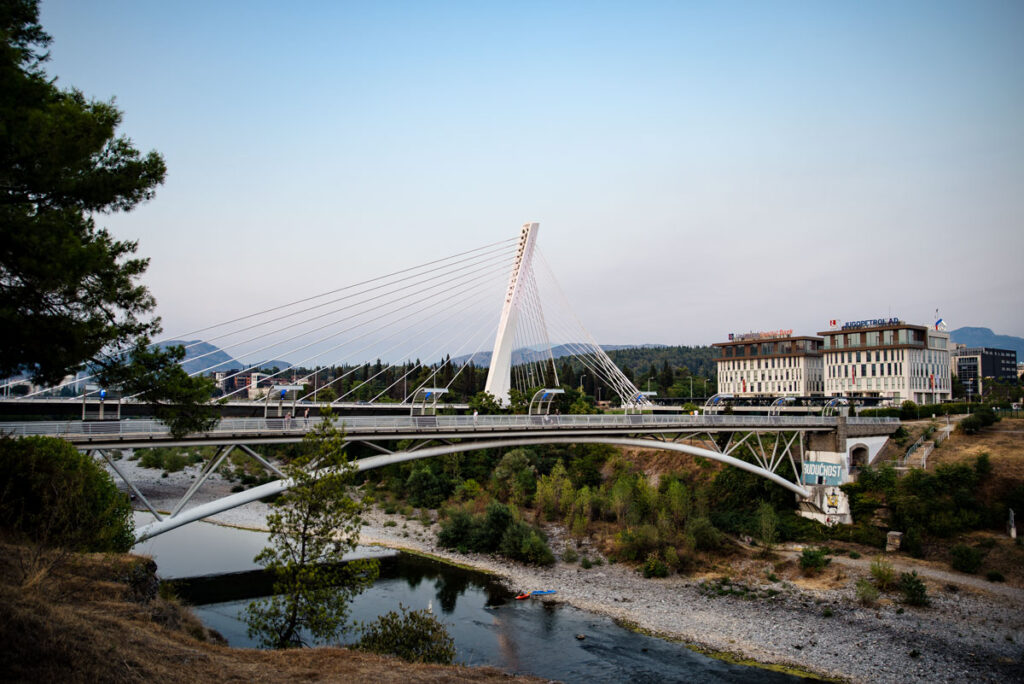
[0,545,539,682]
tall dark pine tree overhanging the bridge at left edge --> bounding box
[0,0,214,434]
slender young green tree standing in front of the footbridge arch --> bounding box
[247,413,378,648]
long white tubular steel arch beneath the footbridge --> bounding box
[136,436,811,542]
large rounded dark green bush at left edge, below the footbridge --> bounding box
[0,437,134,552]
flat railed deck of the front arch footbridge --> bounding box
[0,414,899,448]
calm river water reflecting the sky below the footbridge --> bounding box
[135,514,803,682]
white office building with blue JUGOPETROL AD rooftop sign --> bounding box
[818,318,952,403]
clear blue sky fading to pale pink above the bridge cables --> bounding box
[41,0,1024,352]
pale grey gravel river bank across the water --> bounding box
[112,461,1024,682]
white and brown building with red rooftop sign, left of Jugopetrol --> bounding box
[712,330,824,396]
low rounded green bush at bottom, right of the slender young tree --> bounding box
[352,604,455,665]
